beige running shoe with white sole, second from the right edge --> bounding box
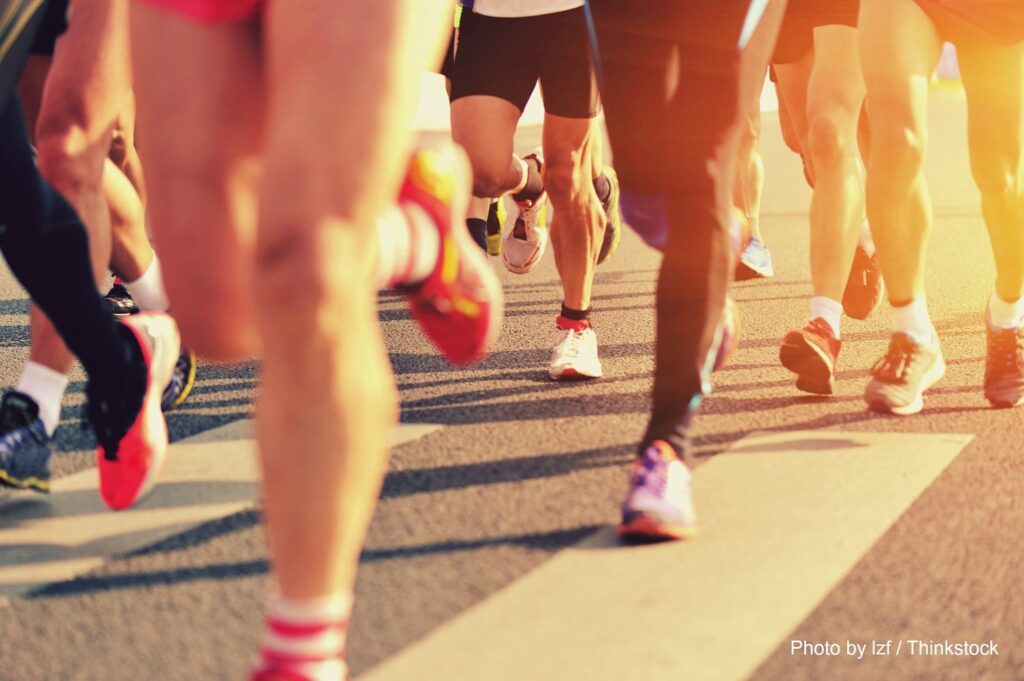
[864,333,946,416]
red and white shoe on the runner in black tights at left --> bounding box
[88,312,181,511]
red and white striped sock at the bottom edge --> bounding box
[252,596,351,681]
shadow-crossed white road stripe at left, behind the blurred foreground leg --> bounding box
[0,420,442,597]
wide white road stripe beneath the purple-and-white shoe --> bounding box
[360,431,973,681]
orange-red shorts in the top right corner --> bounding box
[918,0,1024,44]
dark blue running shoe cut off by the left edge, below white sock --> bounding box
[0,390,52,493]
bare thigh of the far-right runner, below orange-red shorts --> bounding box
[957,43,1024,189]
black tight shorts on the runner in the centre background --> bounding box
[452,7,599,118]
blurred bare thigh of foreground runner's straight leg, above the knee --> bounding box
[259,0,452,228]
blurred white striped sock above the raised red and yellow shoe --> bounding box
[377,202,440,289]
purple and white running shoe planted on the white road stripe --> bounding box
[618,440,697,541]
